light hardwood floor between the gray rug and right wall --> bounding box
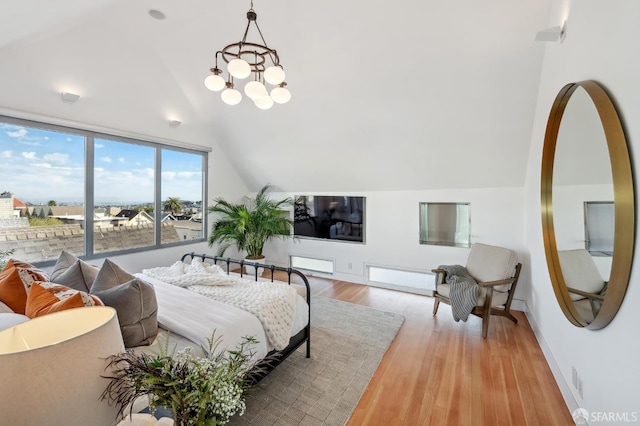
[276,277,574,426]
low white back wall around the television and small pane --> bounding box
[265,188,529,298]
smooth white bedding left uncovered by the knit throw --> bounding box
[135,273,309,359]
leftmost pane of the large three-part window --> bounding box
[0,120,86,262]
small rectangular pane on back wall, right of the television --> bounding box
[420,203,471,247]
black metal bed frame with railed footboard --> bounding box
[180,252,311,383]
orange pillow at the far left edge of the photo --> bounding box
[0,259,48,314]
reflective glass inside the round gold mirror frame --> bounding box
[553,87,615,323]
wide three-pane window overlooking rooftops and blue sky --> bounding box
[0,116,207,263]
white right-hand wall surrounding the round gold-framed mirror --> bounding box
[525,0,640,424]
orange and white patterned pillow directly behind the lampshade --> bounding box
[25,282,103,318]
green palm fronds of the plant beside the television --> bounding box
[209,185,293,259]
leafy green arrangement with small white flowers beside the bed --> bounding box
[102,333,262,426]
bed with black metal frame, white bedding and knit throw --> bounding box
[135,252,311,381]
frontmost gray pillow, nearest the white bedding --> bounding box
[91,278,158,348]
